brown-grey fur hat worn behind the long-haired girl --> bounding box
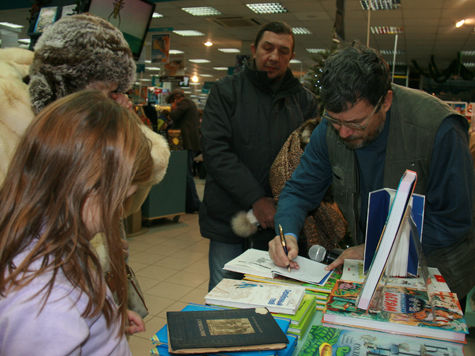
[29,14,135,113]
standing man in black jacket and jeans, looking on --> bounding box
[200,22,318,290]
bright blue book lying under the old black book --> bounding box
[151,303,297,356]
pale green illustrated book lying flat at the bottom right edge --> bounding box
[299,325,463,356]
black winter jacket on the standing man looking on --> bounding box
[200,68,318,243]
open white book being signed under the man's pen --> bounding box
[223,248,332,285]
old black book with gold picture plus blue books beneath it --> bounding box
[151,303,297,356]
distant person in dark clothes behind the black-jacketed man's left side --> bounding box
[167,89,201,213]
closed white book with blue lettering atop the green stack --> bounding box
[205,278,305,314]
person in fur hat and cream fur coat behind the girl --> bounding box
[0,14,170,329]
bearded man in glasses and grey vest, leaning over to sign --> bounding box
[269,44,475,298]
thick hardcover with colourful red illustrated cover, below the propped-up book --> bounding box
[322,280,468,343]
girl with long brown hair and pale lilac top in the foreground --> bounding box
[0,91,153,356]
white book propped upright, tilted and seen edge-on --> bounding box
[356,170,417,309]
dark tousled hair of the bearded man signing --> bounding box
[320,43,391,113]
